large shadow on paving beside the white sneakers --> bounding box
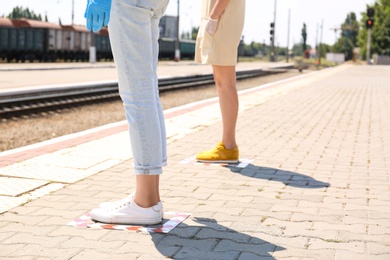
[150,217,285,260]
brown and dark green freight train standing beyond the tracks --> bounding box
[0,18,195,62]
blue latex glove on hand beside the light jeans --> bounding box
[84,0,111,32]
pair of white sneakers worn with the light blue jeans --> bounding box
[91,197,162,225]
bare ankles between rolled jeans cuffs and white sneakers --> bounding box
[134,175,160,208]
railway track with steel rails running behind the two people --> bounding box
[0,67,288,119]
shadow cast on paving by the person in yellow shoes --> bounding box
[228,164,330,189]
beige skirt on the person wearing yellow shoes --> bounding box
[195,0,245,66]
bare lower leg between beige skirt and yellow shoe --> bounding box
[213,65,238,149]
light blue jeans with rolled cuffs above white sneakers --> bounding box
[109,0,169,175]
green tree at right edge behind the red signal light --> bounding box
[358,0,390,59]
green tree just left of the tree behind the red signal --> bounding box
[332,12,359,60]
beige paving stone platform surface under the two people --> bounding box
[0,65,390,260]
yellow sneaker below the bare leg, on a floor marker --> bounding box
[196,142,239,163]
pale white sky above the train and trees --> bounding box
[0,0,375,48]
